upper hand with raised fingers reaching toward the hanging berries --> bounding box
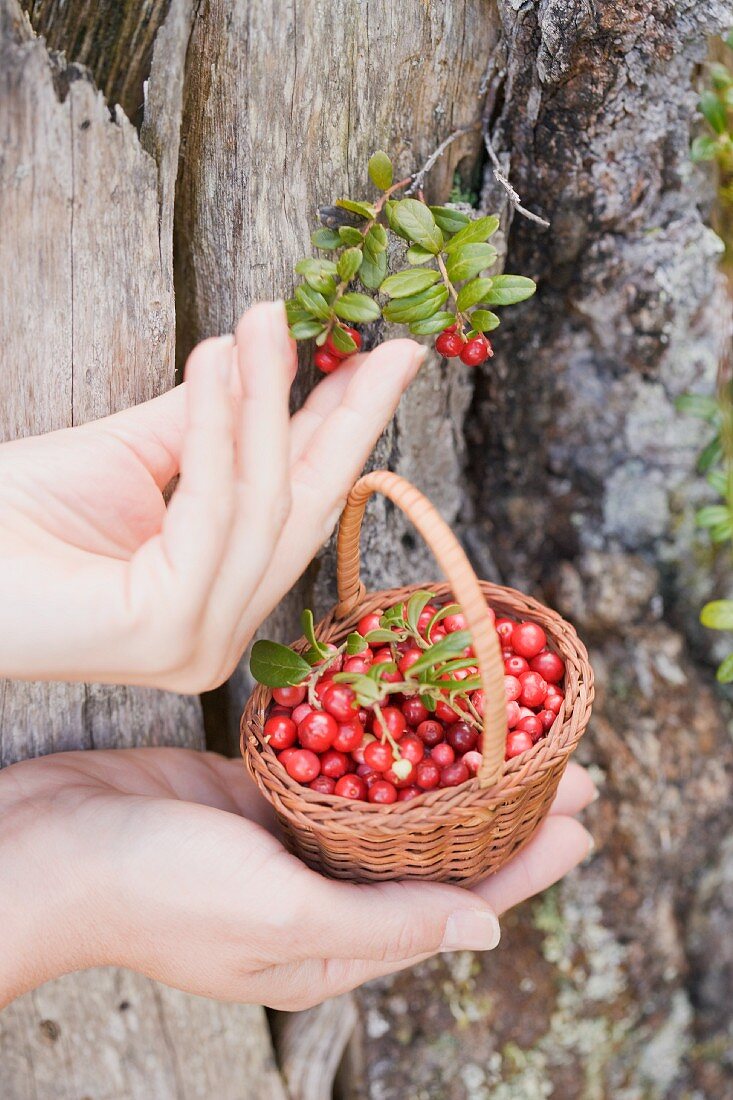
[0,303,424,692]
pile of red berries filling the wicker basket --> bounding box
[259,604,565,804]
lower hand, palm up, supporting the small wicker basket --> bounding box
[0,749,595,1010]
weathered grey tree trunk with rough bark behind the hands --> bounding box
[0,0,733,1100]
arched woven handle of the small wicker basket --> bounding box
[336,470,506,787]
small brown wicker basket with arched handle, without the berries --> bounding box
[241,471,593,886]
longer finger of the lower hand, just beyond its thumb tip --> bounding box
[473,815,593,915]
